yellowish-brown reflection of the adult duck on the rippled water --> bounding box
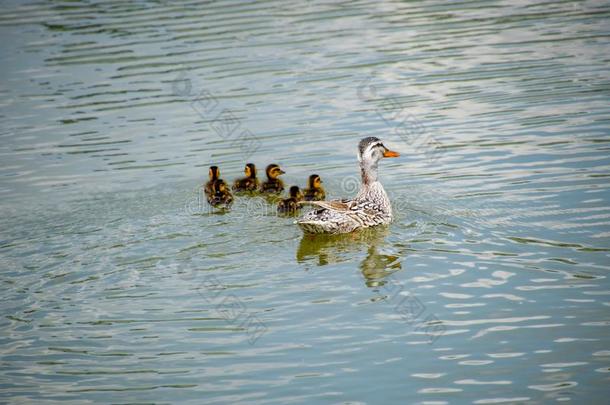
[297,226,402,287]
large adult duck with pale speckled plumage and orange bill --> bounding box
[297,137,400,233]
